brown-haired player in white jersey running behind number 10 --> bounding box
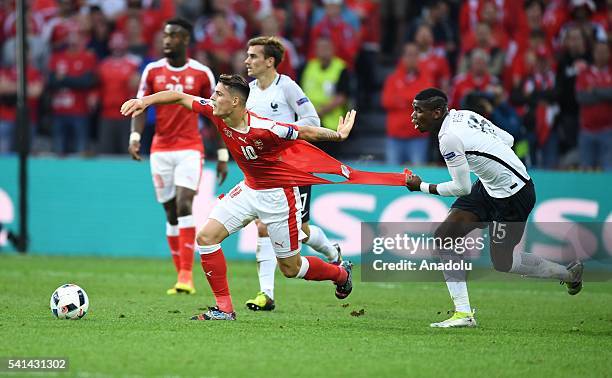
[244,37,340,311]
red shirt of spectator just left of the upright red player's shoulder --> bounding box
[98,56,138,119]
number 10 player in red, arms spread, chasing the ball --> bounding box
[121,75,356,320]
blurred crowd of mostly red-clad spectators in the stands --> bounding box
[0,0,612,170]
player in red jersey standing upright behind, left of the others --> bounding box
[128,19,228,294]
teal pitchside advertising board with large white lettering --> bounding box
[0,157,612,272]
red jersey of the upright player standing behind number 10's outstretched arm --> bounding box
[137,58,215,153]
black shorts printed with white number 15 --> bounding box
[451,180,536,250]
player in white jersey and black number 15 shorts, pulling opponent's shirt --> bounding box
[406,88,583,328]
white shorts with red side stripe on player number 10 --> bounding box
[209,181,306,259]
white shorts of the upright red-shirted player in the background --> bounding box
[150,150,204,203]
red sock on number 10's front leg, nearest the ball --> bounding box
[200,249,234,312]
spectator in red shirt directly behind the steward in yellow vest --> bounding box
[309,0,360,68]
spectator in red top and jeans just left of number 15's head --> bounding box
[382,43,433,165]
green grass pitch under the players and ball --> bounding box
[0,255,612,377]
